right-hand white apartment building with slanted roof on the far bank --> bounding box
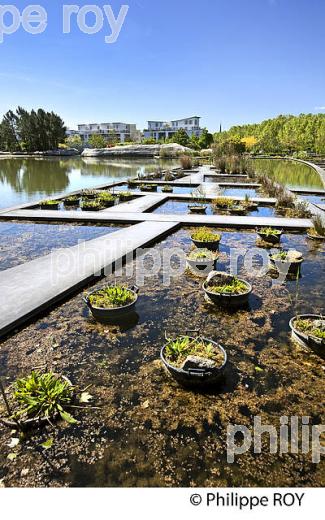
[143,116,202,141]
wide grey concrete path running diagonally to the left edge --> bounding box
[0,221,178,336]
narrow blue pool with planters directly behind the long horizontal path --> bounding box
[152,200,276,217]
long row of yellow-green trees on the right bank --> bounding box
[214,114,325,154]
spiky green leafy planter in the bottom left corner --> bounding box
[0,371,77,430]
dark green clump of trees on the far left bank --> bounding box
[0,107,66,152]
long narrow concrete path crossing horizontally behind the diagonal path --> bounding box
[1,210,312,230]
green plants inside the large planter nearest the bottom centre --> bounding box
[165,336,224,367]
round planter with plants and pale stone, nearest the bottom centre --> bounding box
[160,336,227,386]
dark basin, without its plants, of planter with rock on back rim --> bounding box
[202,271,253,308]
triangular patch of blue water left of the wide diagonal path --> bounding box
[0,222,120,271]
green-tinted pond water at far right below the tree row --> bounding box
[252,159,324,189]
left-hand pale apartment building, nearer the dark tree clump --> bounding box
[77,123,141,143]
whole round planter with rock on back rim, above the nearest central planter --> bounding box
[202,271,252,307]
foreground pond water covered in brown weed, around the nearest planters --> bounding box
[0,229,325,487]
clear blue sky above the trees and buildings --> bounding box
[0,0,325,130]
